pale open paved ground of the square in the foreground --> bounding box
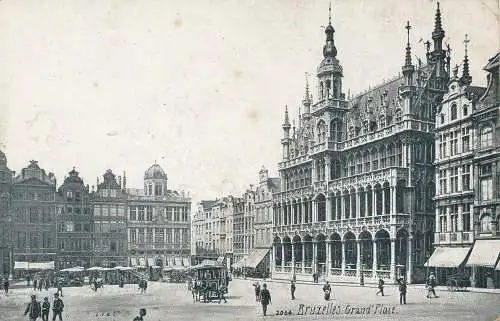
[0,280,500,321]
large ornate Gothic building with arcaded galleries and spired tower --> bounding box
[272,7,450,282]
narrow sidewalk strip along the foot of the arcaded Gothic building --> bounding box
[234,277,500,294]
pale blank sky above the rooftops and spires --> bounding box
[0,0,499,202]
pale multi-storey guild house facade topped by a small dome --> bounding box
[127,164,191,267]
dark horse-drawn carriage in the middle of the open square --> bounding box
[191,260,229,302]
